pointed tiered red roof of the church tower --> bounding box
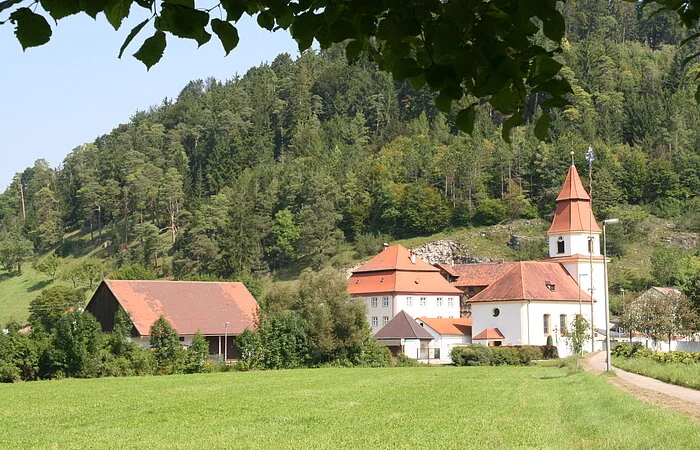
[548,166,601,233]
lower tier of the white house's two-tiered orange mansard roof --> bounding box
[348,271,462,295]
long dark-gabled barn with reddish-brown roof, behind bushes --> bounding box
[85,280,258,359]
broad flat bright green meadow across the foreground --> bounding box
[0,367,700,449]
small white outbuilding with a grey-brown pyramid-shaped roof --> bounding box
[374,311,434,360]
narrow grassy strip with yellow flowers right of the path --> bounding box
[612,357,700,390]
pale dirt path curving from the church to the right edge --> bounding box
[581,352,700,423]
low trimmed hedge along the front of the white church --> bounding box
[450,344,559,366]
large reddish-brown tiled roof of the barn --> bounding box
[91,280,258,336]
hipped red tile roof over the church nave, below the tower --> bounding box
[469,261,591,303]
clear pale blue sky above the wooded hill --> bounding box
[0,7,299,192]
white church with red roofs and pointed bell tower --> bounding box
[443,164,607,355]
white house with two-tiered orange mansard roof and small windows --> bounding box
[348,245,462,331]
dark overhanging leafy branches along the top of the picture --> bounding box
[0,0,700,139]
